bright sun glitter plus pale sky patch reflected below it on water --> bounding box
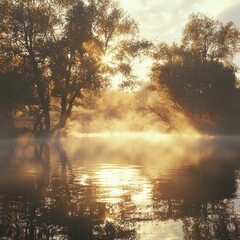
[72,160,183,240]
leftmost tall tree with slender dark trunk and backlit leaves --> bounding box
[0,0,60,131]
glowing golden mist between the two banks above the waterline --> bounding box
[66,88,199,137]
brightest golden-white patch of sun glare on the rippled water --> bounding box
[93,164,152,204]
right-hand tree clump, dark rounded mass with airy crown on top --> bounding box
[152,14,240,118]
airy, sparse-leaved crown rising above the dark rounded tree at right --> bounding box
[182,13,240,63]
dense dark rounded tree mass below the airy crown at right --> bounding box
[152,44,236,118]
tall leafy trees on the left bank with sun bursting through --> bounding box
[0,0,149,131]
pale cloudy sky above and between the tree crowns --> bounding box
[120,0,240,80]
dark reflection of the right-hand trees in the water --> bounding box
[153,159,240,240]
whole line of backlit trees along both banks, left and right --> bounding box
[0,0,240,137]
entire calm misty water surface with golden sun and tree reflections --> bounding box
[0,136,240,240]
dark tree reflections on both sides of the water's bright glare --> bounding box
[0,142,240,240]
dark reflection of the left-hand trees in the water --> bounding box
[0,142,136,240]
